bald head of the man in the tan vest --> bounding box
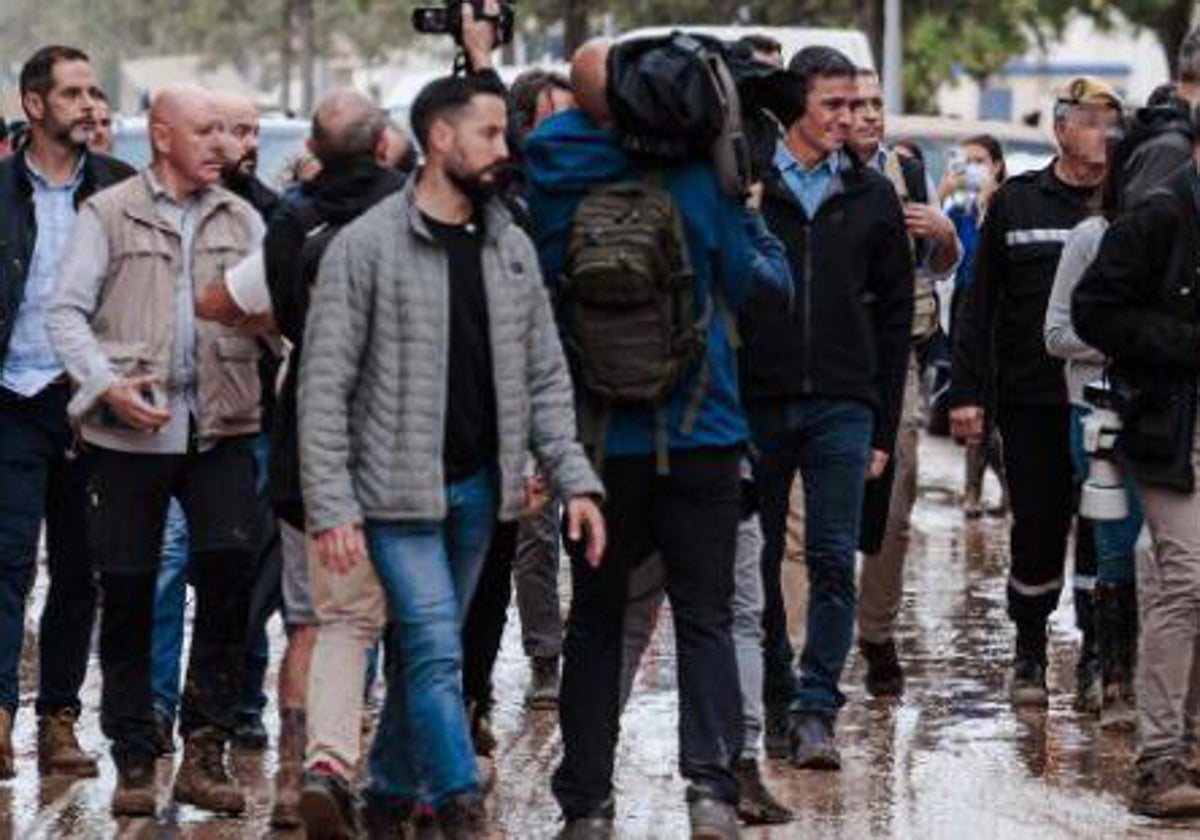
[150,84,227,198]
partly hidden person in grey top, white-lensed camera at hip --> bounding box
[1045,147,1142,728]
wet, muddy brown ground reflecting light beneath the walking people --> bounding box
[0,440,1200,840]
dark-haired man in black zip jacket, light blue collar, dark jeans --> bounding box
[742,47,913,769]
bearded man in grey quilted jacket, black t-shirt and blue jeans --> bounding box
[300,76,605,839]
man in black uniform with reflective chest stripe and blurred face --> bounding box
[950,78,1121,707]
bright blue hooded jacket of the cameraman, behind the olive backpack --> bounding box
[524,110,791,457]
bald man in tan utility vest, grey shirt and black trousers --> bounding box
[47,86,263,816]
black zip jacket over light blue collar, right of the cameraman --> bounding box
[740,151,913,452]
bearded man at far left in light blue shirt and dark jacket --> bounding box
[0,47,133,779]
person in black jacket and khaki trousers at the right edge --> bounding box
[1073,100,1200,817]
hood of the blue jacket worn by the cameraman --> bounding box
[524,109,631,192]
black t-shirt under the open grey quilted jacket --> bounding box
[425,216,497,482]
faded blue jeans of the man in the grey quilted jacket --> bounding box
[366,470,497,808]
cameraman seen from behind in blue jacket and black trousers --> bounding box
[526,42,787,839]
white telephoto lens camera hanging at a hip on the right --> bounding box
[1079,382,1129,521]
